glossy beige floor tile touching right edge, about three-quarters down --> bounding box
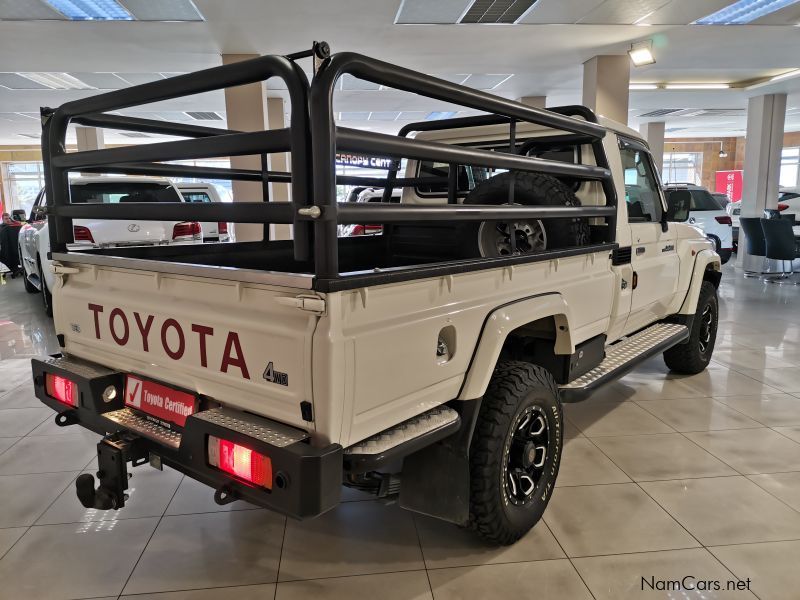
[680,428,800,475]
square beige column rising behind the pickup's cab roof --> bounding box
[583,54,631,125]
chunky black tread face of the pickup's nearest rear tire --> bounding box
[470,361,561,545]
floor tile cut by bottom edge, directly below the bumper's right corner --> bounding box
[276,571,433,600]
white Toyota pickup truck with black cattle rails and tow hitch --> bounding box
[33,43,721,544]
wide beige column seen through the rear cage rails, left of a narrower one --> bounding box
[222,54,266,242]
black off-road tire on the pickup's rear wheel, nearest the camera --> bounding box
[470,361,563,545]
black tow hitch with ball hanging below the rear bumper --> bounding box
[75,432,148,510]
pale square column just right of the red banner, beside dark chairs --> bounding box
[737,94,786,271]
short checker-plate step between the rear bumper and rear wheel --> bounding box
[344,405,461,473]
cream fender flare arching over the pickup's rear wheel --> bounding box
[458,292,575,400]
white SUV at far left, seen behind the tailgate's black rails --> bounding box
[19,177,203,316]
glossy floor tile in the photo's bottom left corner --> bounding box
[0,519,158,600]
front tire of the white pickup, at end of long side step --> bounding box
[664,281,719,375]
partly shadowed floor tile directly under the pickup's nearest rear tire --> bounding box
[414,515,564,569]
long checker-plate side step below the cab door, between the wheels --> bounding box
[559,323,689,391]
